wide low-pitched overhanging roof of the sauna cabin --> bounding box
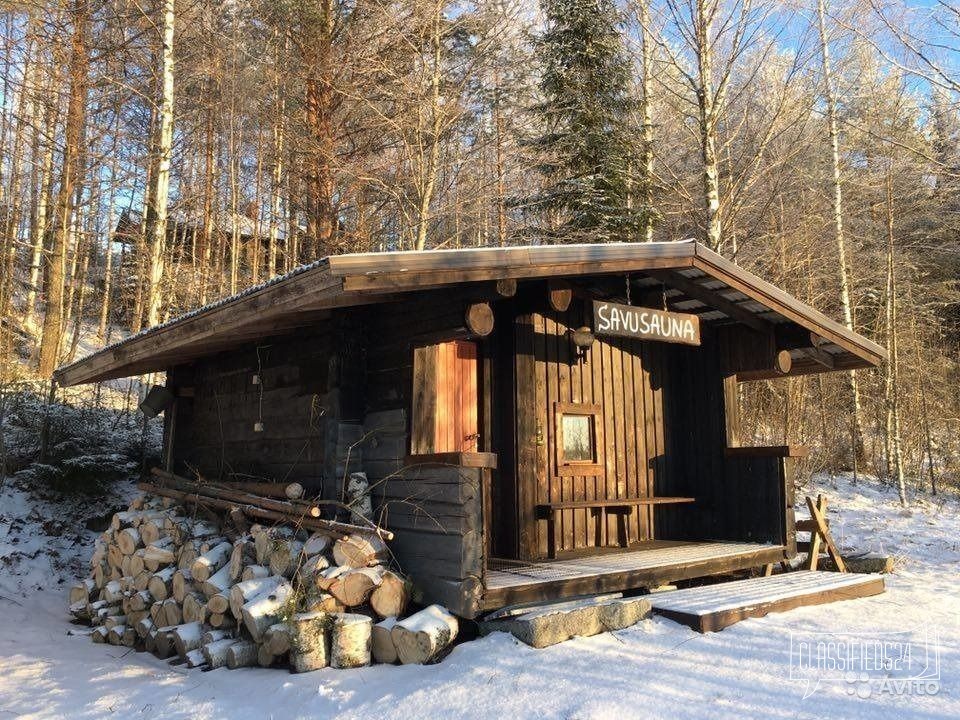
[54,240,886,385]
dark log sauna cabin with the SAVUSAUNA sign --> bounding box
[55,241,884,618]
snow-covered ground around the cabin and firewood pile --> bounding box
[0,480,960,720]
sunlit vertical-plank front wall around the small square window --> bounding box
[516,299,670,558]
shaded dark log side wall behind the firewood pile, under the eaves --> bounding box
[167,315,363,496]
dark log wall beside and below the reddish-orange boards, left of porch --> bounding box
[363,291,485,617]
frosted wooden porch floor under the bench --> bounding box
[484,540,784,609]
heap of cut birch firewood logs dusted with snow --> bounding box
[69,470,458,672]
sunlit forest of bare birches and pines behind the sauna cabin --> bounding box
[0,0,960,498]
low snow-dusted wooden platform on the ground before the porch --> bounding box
[650,570,884,632]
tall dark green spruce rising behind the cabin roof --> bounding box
[524,0,647,242]
